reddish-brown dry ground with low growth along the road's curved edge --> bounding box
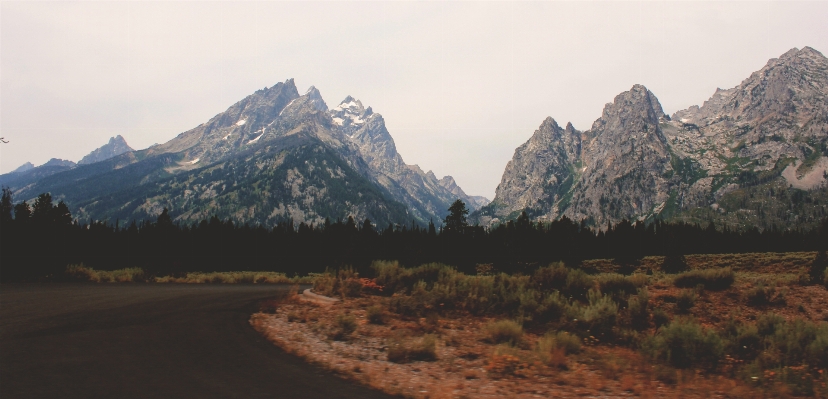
[250,290,750,398]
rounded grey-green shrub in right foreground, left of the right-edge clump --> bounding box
[644,319,724,369]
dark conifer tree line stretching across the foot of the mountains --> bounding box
[0,193,828,281]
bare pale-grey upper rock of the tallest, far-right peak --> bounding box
[671,47,828,179]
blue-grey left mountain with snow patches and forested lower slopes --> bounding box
[0,79,488,226]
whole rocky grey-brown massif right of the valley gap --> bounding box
[473,47,828,228]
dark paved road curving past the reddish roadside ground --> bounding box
[0,284,390,399]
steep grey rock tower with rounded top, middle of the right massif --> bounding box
[560,85,671,226]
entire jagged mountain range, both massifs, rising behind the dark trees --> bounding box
[0,47,828,230]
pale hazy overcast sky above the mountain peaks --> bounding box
[0,1,828,199]
